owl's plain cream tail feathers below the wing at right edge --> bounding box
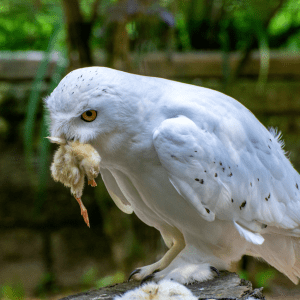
[251,234,300,284]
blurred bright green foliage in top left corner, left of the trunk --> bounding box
[0,0,64,50]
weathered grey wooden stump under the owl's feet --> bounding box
[60,271,265,300]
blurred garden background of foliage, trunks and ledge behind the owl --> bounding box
[0,0,300,299]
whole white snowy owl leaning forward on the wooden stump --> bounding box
[45,67,300,284]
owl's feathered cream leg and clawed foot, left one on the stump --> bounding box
[128,231,185,281]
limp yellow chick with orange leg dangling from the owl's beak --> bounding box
[47,137,101,227]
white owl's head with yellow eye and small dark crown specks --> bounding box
[45,67,140,143]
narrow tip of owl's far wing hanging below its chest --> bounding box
[100,168,133,214]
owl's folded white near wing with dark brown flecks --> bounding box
[153,116,300,244]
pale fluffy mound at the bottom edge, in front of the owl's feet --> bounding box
[114,280,197,300]
